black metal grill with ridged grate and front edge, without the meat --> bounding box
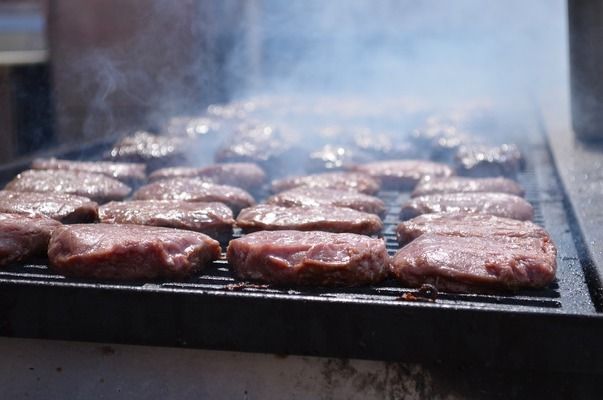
[0,123,603,373]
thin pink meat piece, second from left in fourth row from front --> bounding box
[150,163,266,190]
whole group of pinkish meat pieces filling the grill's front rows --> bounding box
[0,148,556,291]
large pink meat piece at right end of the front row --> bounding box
[391,233,557,292]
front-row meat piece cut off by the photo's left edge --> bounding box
[0,213,61,266]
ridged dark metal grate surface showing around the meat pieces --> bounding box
[0,141,594,313]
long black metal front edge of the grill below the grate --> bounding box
[0,284,603,373]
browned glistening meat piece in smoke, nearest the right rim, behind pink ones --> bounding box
[455,144,525,177]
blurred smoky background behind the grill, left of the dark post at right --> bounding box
[0,0,568,162]
